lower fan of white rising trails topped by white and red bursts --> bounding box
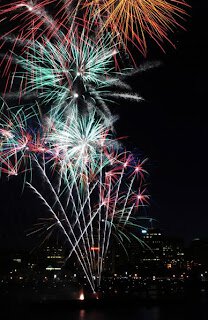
[0,101,148,291]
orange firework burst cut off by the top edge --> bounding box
[84,0,189,55]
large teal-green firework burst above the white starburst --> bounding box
[13,28,136,114]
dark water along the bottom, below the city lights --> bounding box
[0,297,208,320]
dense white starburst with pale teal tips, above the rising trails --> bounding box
[47,109,113,178]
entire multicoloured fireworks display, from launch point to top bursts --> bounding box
[0,0,187,292]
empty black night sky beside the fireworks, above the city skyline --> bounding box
[0,0,208,248]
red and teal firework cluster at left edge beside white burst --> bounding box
[0,99,44,176]
